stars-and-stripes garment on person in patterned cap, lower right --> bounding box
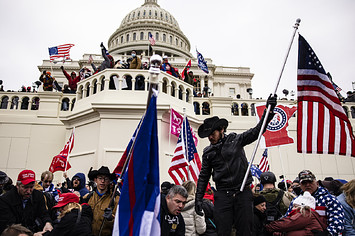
[285,187,345,235]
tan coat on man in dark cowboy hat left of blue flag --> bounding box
[84,192,120,236]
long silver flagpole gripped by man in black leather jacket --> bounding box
[240,19,301,192]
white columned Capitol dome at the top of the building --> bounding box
[108,0,192,58]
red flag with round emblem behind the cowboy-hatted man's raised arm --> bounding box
[256,105,297,147]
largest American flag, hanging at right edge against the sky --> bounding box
[297,35,355,156]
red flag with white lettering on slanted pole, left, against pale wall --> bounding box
[49,128,75,173]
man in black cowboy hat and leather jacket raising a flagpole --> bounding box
[195,95,277,236]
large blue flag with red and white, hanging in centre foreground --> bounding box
[112,93,160,236]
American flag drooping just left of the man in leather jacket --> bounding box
[168,118,201,185]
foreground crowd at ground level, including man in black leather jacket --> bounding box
[0,95,355,236]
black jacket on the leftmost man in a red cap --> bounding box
[0,187,52,234]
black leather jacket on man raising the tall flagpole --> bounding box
[196,113,274,201]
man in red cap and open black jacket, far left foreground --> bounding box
[0,170,53,233]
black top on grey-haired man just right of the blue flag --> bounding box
[160,198,185,236]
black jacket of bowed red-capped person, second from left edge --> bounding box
[43,204,93,236]
